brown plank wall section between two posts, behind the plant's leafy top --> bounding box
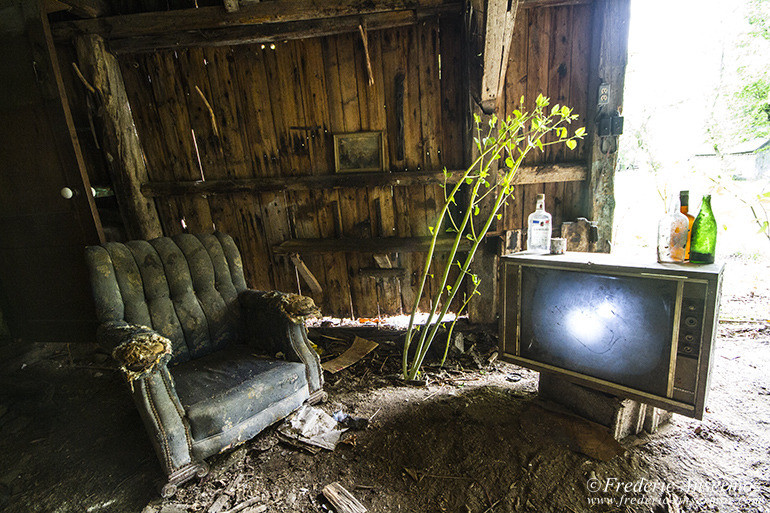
[498,4,593,241]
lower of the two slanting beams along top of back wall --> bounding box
[105,3,460,54]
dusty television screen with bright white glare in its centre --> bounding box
[520,267,677,396]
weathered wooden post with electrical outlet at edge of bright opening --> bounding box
[585,0,630,253]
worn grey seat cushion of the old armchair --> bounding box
[169,345,307,441]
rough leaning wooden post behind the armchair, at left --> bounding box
[75,35,163,239]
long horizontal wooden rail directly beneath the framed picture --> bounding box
[142,163,588,197]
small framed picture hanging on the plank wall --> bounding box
[334,131,385,173]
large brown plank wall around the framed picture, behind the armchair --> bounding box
[115,17,464,317]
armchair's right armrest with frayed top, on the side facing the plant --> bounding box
[238,290,323,394]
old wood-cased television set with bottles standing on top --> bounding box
[500,253,724,419]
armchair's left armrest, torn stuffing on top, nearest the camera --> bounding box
[97,322,194,479]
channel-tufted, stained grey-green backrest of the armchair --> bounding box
[86,232,246,363]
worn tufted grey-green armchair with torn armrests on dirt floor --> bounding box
[86,233,324,496]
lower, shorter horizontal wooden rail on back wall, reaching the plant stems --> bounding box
[273,237,470,255]
